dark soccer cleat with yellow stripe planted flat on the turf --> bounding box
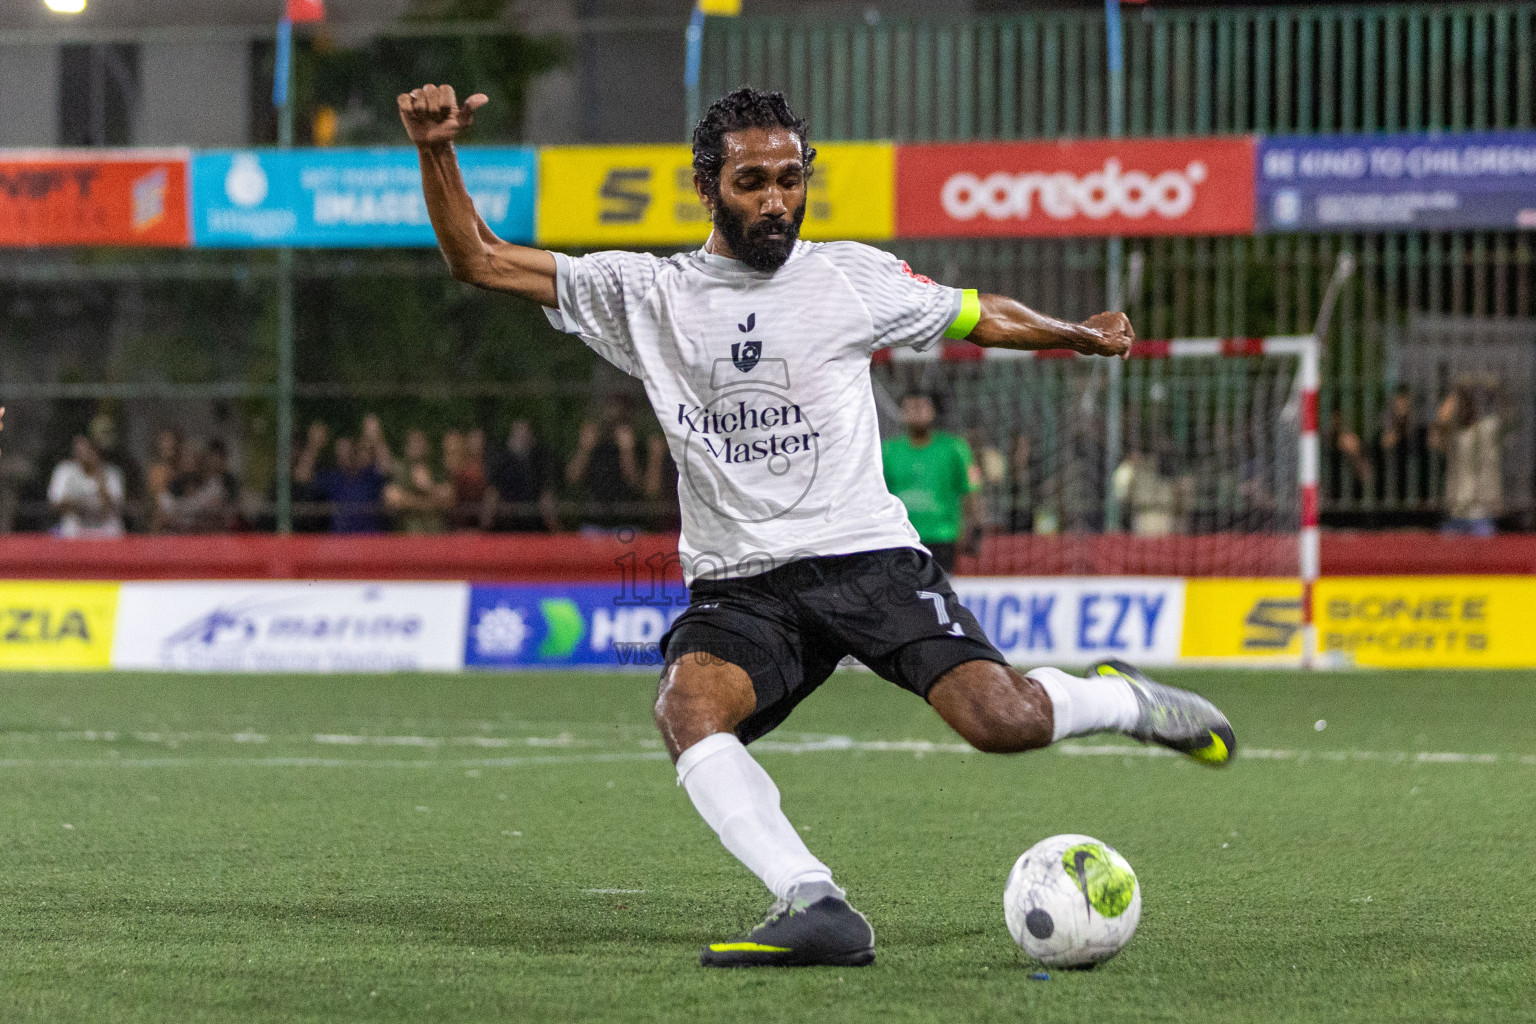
[699,895,874,967]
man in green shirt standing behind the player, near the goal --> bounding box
[882,391,982,573]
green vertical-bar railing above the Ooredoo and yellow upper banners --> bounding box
[702,3,1536,141]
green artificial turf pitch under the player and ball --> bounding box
[0,672,1536,1024]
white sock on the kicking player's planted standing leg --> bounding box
[677,732,842,900]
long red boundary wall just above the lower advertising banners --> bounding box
[0,531,1517,582]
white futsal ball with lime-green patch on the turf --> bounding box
[1003,835,1141,967]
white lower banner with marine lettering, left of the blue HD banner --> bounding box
[112,582,468,672]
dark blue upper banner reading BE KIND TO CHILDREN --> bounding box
[1258,132,1536,232]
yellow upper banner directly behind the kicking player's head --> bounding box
[538,143,895,247]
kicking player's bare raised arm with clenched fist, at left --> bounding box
[398,86,559,309]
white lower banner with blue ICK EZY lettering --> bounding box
[954,576,1184,665]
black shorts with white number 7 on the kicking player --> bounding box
[660,548,1008,743]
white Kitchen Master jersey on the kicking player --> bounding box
[545,234,965,583]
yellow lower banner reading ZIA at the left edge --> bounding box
[0,582,117,669]
